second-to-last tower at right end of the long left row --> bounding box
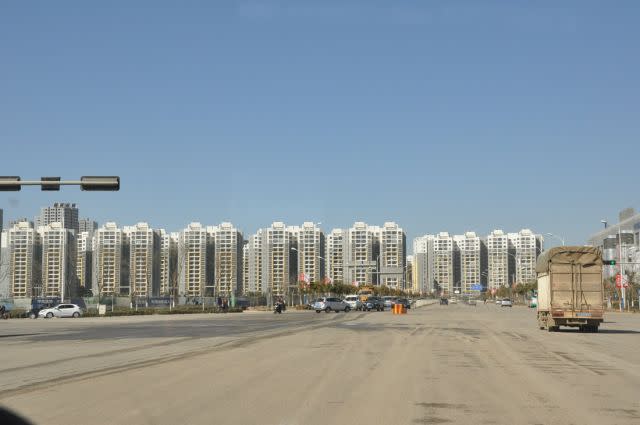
[345,221,379,285]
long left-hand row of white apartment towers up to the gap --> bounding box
[0,220,407,298]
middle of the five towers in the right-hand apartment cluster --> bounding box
[453,232,487,294]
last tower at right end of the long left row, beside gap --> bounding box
[378,222,407,289]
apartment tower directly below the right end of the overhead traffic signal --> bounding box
[93,222,126,295]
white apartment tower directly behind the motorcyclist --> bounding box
[266,221,296,296]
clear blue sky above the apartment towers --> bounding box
[0,0,640,244]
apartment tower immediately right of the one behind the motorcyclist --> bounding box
[293,221,326,282]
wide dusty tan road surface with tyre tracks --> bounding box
[0,304,640,425]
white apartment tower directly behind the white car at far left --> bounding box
[38,222,76,300]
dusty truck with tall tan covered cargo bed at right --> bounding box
[536,246,604,332]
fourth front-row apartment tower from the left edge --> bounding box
[123,223,160,298]
